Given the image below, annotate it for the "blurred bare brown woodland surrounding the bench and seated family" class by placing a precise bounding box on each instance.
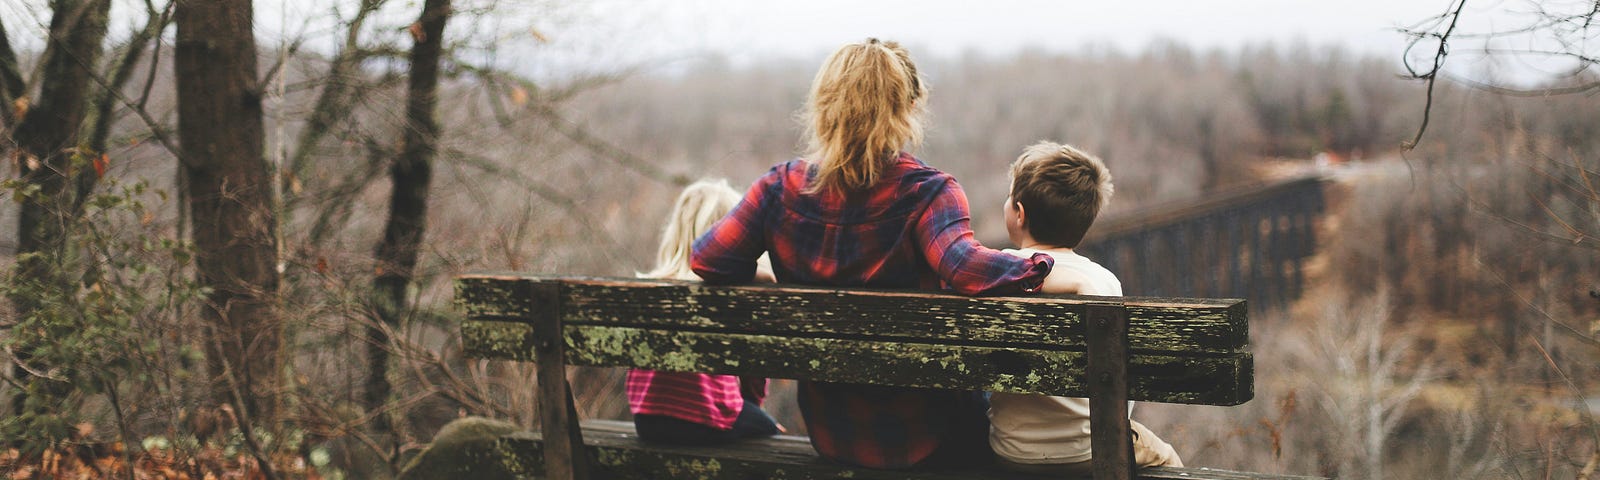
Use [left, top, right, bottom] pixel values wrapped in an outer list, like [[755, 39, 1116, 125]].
[[0, 0, 1600, 478]]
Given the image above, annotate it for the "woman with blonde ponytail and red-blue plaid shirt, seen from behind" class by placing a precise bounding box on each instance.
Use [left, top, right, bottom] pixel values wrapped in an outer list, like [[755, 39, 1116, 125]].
[[691, 38, 1053, 469]]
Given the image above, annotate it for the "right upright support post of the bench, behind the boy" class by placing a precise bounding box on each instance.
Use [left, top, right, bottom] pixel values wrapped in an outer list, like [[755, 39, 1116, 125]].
[[1083, 304, 1134, 480]]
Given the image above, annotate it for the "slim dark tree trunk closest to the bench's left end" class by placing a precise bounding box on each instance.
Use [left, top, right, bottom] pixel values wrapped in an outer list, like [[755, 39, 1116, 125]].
[[365, 0, 450, 430]]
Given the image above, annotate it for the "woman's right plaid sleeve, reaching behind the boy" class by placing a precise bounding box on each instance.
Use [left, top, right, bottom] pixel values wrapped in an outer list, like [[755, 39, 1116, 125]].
[[915, 179, 1056, 294]]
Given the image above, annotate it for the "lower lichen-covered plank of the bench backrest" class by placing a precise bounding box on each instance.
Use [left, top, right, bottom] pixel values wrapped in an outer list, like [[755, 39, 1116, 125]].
[[544, 322, 1253, 405]]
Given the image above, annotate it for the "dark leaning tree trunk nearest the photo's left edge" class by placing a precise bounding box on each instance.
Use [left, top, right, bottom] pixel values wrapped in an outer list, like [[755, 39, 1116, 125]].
[[0, 0, 110, 413]]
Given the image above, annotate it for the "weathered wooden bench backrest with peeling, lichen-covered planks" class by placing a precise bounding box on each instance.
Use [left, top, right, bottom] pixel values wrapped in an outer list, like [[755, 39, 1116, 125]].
[[456, 274, 1254, 405]]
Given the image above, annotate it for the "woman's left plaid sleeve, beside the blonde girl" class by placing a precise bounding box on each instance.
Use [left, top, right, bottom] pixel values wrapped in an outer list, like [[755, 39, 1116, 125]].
[[690, 170, 778, 285]]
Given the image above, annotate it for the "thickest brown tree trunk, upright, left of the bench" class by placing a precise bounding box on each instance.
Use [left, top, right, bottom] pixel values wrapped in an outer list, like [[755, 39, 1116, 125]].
[[174, 0, 283, 424]]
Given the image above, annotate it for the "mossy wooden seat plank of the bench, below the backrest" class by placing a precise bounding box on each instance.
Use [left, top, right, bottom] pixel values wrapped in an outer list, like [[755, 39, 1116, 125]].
[[498, 422, 1314, 480]]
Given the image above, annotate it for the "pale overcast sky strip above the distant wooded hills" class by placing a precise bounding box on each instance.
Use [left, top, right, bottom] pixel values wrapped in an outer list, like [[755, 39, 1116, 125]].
[[492, 0, 1568, 81]]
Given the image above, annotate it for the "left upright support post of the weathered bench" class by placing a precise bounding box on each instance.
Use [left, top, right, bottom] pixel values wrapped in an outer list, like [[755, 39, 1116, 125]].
[[528, 283, 589, 480]]
